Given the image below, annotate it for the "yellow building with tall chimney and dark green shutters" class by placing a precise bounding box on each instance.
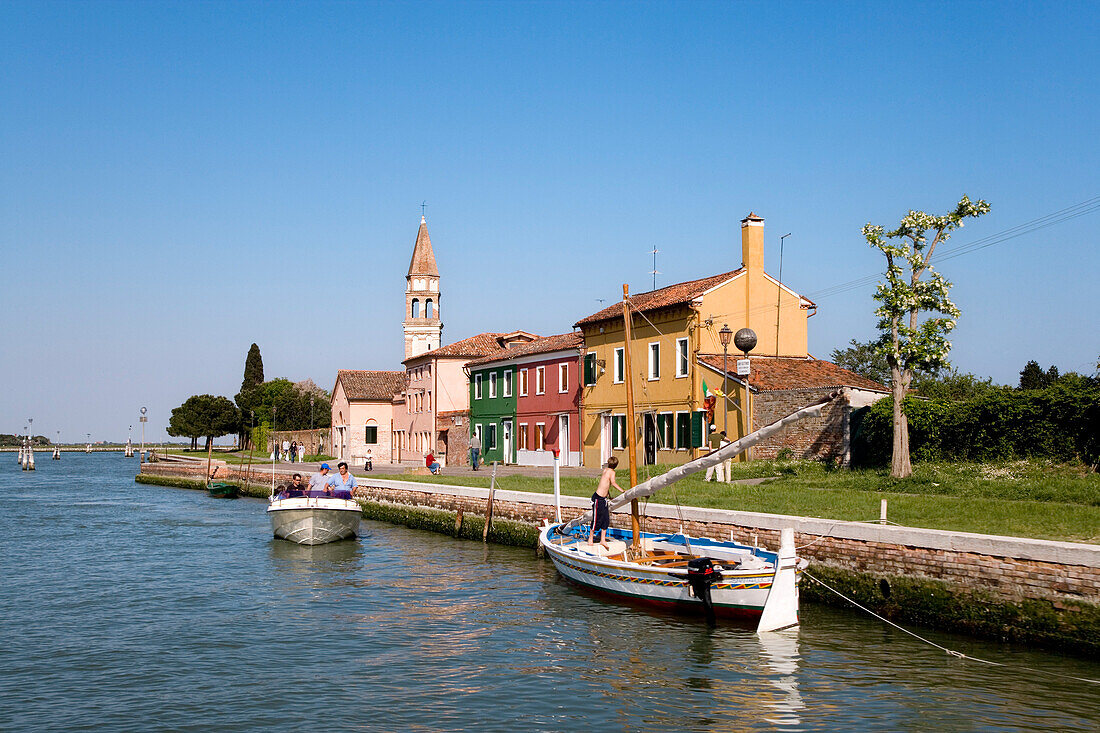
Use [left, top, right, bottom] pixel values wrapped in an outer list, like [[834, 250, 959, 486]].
[[575, 214, 816, 466]]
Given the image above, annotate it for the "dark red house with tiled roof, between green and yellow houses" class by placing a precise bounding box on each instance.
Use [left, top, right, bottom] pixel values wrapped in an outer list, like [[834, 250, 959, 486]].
[[466, 332, 584, 466]]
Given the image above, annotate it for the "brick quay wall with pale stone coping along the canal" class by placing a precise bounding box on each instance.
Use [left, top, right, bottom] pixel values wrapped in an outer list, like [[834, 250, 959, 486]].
[[142, 461, 1100, 657]]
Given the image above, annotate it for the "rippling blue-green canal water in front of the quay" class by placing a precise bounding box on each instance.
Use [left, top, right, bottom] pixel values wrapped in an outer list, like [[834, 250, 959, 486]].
[[0, 453, 1100, 731]]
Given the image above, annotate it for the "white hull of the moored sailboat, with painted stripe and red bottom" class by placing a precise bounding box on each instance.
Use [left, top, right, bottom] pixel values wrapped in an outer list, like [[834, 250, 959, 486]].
[[539, 526, 805, 619]]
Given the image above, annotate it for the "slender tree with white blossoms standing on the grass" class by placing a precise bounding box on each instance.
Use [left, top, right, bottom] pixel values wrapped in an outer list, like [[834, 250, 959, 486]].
[[864, 196, 989, 479]]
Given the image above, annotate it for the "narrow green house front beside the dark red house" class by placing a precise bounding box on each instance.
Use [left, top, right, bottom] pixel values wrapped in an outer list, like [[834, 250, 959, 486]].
[[470, 363, 516, 463]]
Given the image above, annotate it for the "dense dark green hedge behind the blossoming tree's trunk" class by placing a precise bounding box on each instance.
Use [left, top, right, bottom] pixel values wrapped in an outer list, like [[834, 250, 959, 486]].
[[851, 384, 1100, 466]]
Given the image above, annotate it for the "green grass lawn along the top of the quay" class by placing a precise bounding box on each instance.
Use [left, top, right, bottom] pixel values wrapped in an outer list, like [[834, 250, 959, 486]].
[[385, 460, 1100, 543]]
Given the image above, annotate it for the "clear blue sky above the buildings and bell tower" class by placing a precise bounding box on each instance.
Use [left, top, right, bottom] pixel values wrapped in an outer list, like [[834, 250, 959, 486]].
[[0, 2, 1100, 440]]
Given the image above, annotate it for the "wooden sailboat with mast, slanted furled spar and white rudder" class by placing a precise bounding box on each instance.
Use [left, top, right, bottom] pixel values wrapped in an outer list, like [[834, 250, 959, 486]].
[[539, 285, 835, 632]]
